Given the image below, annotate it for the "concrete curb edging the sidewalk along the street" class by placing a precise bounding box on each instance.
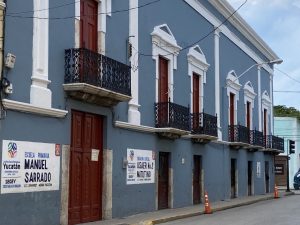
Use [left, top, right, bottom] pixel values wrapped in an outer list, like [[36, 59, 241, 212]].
[[149, 192, 295, 225]]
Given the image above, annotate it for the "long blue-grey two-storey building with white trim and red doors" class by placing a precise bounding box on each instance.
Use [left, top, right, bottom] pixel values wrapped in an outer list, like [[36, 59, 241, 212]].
[[0, 0, 283, 225]]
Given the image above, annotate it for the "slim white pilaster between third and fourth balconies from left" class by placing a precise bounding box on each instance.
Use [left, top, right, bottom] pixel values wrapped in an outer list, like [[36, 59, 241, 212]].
[[214, 29, 222, 140]]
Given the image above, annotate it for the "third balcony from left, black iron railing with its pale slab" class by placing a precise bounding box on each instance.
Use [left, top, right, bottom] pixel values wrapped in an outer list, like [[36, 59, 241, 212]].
[[191, 113, 218, 143]]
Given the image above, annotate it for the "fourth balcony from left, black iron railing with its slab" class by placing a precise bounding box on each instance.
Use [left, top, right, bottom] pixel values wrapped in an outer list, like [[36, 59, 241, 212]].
[[228, 125, 250, 148]]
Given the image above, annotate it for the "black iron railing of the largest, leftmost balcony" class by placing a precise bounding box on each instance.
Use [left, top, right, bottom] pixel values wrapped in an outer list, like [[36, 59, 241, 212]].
[[65, 48, 131, 96]]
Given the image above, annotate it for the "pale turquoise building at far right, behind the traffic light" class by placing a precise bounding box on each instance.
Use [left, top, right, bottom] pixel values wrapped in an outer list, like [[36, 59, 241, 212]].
[[274, 117, 300, 188]]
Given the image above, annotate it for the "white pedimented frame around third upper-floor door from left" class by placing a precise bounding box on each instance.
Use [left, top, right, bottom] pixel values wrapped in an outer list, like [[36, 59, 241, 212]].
[[187, 45, 210, 113]]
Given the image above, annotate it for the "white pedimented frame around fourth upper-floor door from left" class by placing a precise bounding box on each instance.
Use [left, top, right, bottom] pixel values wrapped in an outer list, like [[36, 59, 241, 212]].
[[226, 70, 242, 125]]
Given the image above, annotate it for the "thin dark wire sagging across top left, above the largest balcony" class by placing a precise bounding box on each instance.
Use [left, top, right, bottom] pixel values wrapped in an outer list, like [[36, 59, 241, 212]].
[[6, 0, 162, 20]]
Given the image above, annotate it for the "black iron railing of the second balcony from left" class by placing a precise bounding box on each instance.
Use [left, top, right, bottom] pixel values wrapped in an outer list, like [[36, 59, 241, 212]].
[[155, 101, 190, 131]]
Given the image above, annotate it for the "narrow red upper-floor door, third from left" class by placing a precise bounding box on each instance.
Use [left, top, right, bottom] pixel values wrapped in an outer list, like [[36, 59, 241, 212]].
[[193, 73, 200, 130]]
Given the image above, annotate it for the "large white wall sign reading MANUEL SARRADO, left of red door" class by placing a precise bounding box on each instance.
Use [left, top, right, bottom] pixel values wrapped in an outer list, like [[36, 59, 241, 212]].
[[1, 140, 60, 194]]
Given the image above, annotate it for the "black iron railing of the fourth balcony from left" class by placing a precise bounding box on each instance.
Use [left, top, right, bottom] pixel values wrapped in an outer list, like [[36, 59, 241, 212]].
[[228, 125, 250, 144]]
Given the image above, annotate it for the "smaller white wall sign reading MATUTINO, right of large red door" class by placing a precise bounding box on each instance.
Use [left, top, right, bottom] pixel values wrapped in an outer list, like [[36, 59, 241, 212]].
[[126, 149, 155, 184]]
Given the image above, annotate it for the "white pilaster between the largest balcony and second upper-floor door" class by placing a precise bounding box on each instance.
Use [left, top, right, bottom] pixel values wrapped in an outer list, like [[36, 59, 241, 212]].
[[128, 0, 141, 125]]
